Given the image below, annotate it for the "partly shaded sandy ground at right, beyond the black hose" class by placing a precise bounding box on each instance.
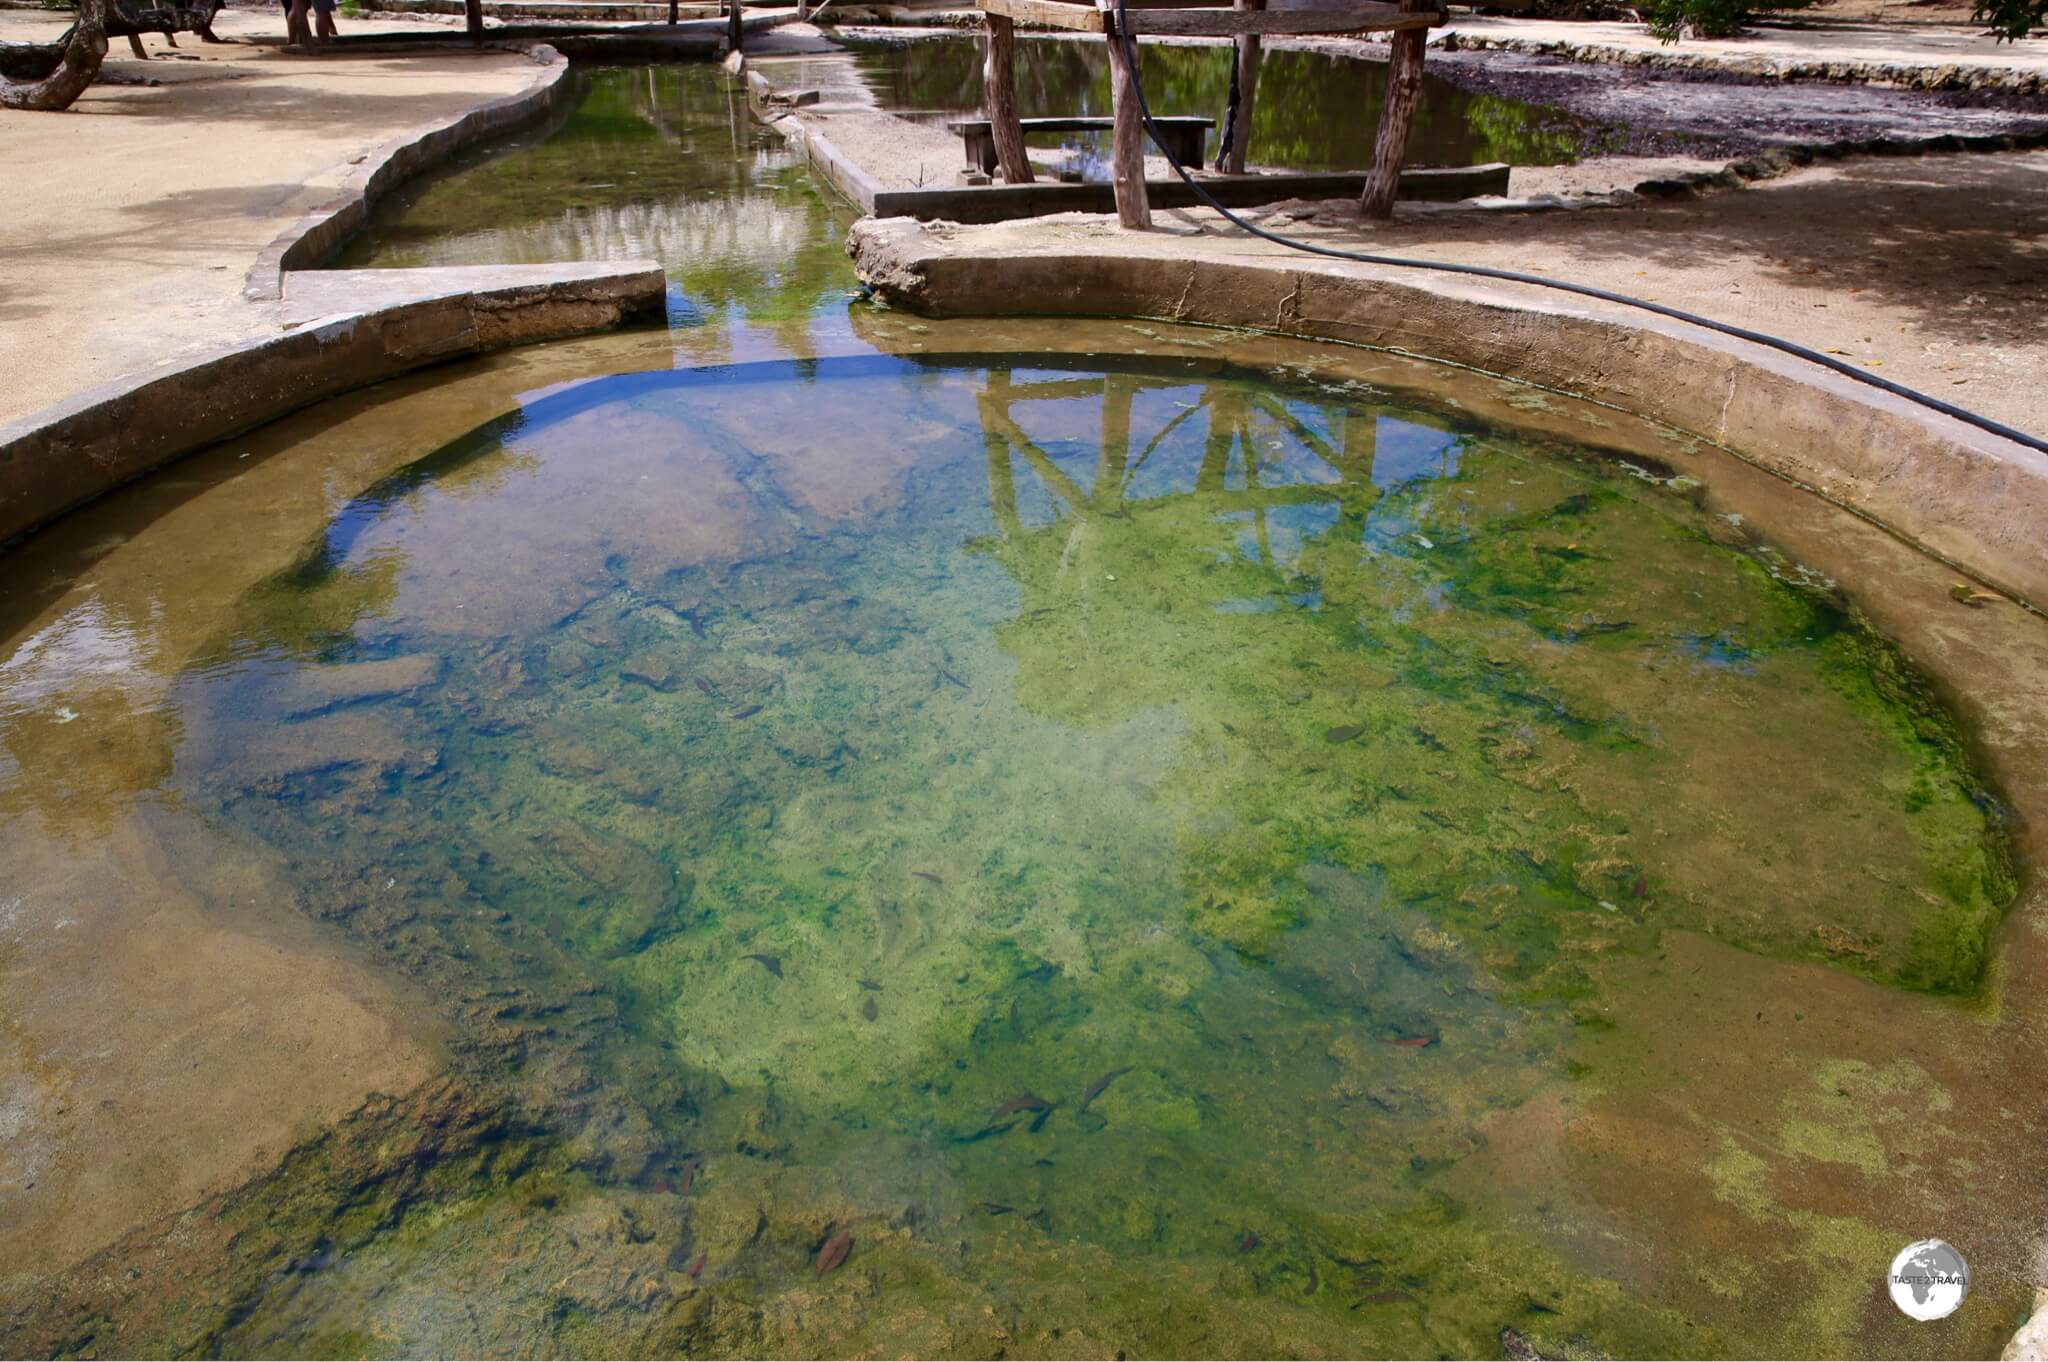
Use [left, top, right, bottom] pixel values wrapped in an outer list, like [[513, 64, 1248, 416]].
[[1210, 152, 2048, 434]]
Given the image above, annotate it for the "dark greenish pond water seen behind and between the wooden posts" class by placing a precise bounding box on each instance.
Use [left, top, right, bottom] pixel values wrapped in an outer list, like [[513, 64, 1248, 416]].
[[846, 37, 1602, 178]]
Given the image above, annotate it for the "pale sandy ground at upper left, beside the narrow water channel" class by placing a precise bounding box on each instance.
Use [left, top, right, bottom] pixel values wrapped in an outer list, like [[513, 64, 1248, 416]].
[[0, 10, 537, 424]]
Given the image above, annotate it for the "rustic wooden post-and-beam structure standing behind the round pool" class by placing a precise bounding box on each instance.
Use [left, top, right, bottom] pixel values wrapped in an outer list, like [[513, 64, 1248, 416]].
[[977, 0, 1444, 227]]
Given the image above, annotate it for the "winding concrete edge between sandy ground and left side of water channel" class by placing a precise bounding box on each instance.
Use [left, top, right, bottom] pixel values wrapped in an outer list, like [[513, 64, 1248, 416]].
[[242, 43, 569, 303]]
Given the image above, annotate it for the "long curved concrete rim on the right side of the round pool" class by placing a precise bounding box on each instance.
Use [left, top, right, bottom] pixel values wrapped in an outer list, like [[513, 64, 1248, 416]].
[[848, 217, 2048, 608]]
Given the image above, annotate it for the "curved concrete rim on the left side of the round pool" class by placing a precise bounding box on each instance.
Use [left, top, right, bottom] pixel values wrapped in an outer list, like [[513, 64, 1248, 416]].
[[0, 260, 668, 543]]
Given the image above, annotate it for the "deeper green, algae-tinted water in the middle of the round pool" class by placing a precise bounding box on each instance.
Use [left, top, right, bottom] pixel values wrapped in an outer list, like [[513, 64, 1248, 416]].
[[108, 356, 2011, 1354]]
